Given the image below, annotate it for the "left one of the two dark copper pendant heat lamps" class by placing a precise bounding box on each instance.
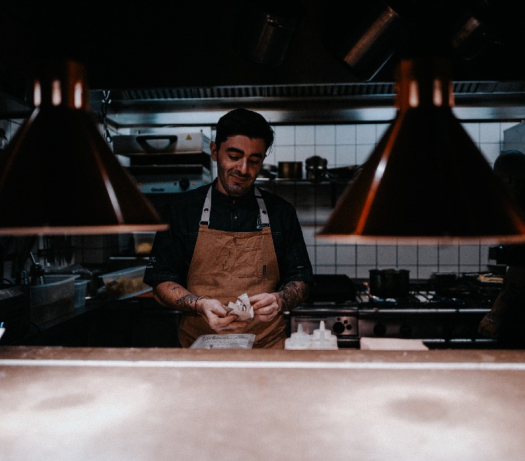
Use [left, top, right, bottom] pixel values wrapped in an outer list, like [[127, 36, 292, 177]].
[[0, 61, 167, 235]]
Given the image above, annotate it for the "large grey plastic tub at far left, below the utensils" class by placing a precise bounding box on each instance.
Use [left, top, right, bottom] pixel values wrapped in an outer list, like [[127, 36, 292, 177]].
[[29, 275, 79, 324]]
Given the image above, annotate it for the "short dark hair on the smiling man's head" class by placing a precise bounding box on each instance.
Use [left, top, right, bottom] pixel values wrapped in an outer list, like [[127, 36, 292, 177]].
[[215, 108, 275, 155]]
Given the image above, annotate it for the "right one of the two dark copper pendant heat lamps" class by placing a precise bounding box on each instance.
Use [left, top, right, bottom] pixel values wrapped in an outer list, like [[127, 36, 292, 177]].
[[317, 57, 525, 244]]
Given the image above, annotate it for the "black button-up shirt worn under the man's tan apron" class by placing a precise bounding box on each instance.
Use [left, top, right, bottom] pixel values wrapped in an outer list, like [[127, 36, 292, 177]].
[[144, 183, 313, 289]]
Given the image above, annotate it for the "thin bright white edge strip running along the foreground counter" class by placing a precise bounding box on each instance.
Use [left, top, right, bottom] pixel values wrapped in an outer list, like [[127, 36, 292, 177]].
[[0, 359, 525, 371]]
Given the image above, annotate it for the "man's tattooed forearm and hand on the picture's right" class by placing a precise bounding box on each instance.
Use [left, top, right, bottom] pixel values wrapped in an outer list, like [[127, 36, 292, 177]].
[[250, 282, 309, 322]]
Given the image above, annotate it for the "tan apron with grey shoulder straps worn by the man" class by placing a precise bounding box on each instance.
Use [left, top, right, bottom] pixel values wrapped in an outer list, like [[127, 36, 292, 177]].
[[179, 186, 286, 348]]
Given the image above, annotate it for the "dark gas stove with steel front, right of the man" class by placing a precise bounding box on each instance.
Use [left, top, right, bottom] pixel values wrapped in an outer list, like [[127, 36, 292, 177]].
[[290, 274, 502, 349]]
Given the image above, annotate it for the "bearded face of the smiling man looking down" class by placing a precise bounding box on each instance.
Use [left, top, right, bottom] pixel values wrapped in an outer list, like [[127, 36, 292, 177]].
[[210, 135, 266, 197]]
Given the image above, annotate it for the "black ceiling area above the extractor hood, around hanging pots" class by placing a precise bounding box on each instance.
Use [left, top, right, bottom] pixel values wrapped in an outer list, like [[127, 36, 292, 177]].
[[0, 0, 525, 89]]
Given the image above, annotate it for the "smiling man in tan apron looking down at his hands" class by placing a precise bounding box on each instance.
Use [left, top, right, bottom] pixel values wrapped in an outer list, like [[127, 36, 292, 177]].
[[144, 108, 313, 348]]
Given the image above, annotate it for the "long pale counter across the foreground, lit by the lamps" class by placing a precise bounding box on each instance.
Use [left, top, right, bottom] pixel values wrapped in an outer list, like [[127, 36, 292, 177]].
[[0, 347, 525, 461]]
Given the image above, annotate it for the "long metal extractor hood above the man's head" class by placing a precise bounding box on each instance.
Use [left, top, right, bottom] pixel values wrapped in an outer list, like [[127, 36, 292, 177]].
[[91, 80, 525, 128]]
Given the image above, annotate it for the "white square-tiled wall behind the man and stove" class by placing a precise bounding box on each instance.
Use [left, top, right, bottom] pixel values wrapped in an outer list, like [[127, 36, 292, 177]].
[[2, 121, 510, 279]]
